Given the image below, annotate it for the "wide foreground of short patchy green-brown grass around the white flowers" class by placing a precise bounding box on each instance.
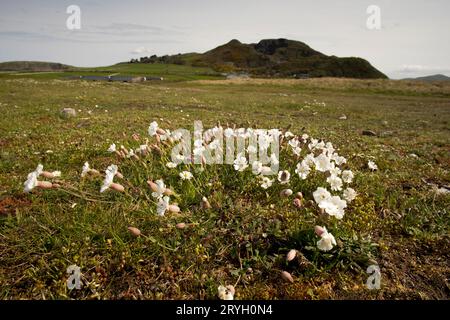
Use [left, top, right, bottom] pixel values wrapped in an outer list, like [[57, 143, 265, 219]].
[[0, 76, 450, 299]]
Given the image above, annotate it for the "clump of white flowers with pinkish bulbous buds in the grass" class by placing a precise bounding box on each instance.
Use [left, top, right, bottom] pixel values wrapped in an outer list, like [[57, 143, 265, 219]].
[[24, 121, 377, 255]]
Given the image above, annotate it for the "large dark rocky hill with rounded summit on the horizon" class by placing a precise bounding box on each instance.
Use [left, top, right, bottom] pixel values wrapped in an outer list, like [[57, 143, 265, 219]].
[[133, 39, 387, 79]]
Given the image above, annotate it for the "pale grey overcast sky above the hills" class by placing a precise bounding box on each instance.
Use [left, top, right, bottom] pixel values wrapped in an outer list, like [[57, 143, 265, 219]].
[[0, 0, 450, 78]]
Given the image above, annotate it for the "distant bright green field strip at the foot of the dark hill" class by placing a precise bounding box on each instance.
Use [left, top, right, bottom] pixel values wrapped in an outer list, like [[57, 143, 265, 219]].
[[0, 63, 223, 81]]
